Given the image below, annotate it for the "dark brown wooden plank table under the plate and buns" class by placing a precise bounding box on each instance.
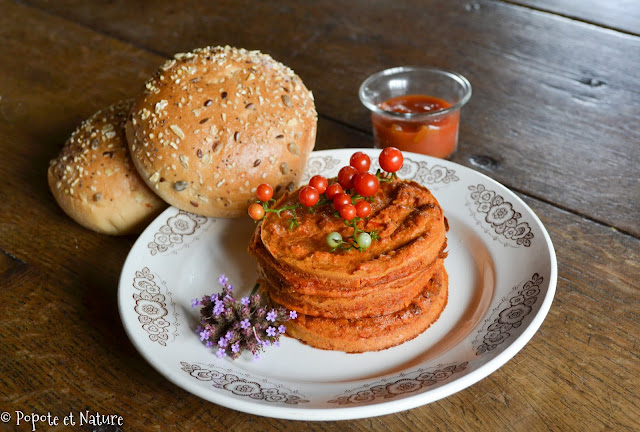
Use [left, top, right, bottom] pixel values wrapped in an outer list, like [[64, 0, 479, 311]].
[[0, 0, 640, 431]]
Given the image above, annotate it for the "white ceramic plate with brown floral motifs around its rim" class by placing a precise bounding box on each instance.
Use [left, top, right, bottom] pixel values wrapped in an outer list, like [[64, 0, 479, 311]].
[[118, 149, 557, 420]]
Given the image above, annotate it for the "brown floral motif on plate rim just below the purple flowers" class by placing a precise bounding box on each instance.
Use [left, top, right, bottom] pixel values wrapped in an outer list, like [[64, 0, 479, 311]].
[[180, 362, 309, 405]]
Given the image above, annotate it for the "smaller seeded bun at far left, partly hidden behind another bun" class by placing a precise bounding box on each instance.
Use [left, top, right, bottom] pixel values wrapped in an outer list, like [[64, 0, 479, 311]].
[[48, 101, 166, 235]]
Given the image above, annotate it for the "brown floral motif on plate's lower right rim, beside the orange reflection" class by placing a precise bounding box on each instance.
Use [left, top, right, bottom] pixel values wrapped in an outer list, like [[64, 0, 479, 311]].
[[476, 273, 544, 355]]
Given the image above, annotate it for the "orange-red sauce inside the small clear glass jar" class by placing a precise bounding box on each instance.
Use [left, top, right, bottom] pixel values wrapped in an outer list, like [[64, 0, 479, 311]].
[[371, 95, 460, 158]]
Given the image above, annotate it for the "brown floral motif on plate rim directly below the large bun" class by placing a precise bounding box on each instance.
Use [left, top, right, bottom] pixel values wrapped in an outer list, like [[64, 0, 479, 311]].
[[147, 210, 214, 255]]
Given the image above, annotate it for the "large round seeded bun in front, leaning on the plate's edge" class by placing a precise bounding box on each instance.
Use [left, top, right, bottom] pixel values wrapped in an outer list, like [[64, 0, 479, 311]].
[[126, 46, 317, 217]]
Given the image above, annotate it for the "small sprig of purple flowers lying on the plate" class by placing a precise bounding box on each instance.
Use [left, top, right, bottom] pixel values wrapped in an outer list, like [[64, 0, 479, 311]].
[[191, 275, 297, 360]]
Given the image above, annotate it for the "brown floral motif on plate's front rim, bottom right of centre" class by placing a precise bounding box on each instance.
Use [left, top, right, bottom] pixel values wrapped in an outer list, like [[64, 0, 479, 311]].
[[329, 362, 468, 405]]
